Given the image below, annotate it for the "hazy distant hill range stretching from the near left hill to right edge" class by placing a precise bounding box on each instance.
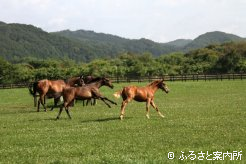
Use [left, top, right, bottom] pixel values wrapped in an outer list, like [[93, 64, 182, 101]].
[[52, 30, 244, 56]]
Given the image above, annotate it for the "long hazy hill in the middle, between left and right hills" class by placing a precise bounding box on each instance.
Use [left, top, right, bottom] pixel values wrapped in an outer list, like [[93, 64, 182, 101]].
[[54, 30, 178, 56]]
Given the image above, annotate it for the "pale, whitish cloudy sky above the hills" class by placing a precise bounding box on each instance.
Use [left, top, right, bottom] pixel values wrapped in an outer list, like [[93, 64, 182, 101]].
[[0, 0, 246, 43]]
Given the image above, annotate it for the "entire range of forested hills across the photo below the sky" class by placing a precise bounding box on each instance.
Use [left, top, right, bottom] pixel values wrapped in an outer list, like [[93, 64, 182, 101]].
[[0, 22, 243, 63]]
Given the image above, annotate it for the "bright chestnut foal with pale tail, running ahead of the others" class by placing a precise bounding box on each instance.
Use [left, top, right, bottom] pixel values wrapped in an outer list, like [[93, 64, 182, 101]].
[[113, 80, 169, 120]]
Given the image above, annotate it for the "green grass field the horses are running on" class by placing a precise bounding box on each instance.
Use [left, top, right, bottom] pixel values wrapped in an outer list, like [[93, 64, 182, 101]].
[[0, 80, 246, 163]]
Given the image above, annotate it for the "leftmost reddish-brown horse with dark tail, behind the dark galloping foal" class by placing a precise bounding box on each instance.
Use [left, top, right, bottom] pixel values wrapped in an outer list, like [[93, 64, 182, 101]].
[[29, 76, 84, 112]]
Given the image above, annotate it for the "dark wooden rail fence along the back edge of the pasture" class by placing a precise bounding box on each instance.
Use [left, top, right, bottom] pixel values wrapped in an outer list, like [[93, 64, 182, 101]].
[[0, 74, 246, 89]]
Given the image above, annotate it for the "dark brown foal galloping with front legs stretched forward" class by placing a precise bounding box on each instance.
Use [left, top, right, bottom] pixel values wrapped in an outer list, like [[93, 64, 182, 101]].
[[56, 78, 117, 119]]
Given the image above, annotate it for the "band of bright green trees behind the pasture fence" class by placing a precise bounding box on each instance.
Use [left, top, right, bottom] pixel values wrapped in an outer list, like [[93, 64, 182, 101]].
[[0, 42, 246, 84]]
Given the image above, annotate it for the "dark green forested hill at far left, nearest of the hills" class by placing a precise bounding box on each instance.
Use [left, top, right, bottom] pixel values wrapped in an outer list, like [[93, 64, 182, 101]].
[[0, 23, 98, 61]]
